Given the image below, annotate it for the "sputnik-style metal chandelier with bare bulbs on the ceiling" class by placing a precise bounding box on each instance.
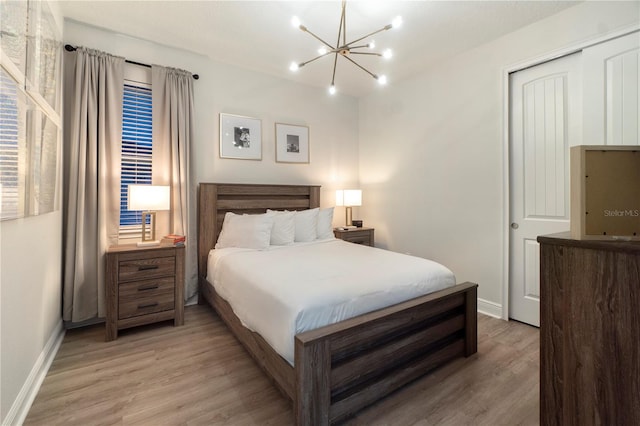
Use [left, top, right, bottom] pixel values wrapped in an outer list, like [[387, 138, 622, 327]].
[[289, 0, 402, 95]]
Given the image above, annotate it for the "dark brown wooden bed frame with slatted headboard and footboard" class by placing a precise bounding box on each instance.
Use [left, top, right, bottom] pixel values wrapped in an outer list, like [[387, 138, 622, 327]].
[[198, 183, 477, 425]]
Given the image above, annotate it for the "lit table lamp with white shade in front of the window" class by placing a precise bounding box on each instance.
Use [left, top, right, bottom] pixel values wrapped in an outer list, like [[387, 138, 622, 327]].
[[127, 185, 171, 247]]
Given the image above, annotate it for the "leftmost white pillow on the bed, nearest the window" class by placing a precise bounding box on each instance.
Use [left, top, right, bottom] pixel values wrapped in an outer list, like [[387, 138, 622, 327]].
[[216, 212, 273, 250]]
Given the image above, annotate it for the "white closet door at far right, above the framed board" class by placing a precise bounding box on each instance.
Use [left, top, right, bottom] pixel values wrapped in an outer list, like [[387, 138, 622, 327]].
[[582, 32, 640, 145]]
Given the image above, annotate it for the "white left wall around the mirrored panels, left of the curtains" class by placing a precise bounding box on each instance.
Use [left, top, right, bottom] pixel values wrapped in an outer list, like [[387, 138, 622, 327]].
[[0, 3, 62, 425]]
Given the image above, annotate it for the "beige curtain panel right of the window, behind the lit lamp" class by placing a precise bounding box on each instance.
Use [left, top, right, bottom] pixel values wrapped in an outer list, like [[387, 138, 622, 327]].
[[151, 65, 198, 300]]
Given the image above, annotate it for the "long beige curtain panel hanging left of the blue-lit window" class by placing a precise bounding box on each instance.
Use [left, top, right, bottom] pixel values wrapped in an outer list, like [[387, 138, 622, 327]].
[[63, 47, 124, 322]]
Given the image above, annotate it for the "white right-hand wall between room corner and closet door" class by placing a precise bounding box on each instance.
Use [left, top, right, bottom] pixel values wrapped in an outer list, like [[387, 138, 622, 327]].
[[359, 2, 640, 312]]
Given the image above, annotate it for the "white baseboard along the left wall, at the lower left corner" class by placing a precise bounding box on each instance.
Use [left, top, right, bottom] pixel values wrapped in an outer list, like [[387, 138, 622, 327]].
[[2, 319, 65, 426]]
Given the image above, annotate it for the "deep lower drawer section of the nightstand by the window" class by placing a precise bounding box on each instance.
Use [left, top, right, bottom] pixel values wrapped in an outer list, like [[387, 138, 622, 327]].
[[118, 277, 175, 319]]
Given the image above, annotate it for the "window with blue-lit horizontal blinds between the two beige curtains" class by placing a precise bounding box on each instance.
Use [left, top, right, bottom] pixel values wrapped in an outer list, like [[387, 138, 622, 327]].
[[120, 80, 153, 237]]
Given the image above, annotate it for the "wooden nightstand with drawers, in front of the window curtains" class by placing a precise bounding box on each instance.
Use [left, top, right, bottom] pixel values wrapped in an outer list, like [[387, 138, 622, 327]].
[[106, 244, 184, 341]]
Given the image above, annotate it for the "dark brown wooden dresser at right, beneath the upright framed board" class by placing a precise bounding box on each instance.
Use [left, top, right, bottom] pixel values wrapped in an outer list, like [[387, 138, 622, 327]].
[[538, 233, 640, 426]]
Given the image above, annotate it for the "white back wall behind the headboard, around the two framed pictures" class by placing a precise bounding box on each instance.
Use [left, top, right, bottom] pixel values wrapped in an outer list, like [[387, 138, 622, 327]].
[[65, 21, 358, 296]]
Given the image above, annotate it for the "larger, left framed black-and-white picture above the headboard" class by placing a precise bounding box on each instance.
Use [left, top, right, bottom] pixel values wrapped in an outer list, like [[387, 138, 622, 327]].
[[220, 113, 262, 160]]
